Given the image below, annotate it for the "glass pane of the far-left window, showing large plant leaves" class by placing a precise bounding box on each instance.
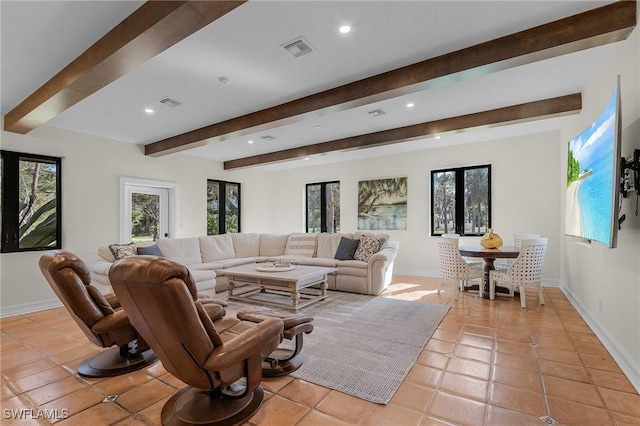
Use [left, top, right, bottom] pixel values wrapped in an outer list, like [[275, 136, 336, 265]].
[[18, 159, 58, 249]]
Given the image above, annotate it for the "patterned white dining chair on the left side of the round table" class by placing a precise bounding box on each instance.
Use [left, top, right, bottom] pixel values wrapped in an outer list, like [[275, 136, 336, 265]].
[[437, 238, 484, 299]]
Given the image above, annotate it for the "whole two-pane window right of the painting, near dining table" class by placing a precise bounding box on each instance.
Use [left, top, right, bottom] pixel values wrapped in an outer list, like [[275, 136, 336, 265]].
[[431, 165, 491, 235]]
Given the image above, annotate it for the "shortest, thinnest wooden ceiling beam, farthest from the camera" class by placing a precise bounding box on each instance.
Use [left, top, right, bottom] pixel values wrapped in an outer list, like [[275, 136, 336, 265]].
[[224, 93, 582, 170]]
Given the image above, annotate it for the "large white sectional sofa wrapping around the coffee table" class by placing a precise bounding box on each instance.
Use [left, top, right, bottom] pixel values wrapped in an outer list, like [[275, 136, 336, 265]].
[[83, 232, 399, 295]]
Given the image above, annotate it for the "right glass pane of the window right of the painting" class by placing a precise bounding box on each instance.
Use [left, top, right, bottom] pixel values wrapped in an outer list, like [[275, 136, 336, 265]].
[[464, 167, 489, 234]]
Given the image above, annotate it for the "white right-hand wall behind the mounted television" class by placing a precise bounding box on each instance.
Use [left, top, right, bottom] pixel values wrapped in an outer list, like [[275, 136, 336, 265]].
[[559, 28, 640, 391]]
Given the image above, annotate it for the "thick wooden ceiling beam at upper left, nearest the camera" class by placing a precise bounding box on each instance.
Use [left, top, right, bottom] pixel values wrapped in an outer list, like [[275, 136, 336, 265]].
[[4, 0, 246, 134]]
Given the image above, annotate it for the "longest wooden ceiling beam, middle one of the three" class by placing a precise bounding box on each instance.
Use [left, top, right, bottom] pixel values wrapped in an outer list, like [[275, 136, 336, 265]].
[[145, 1, 636, 156]]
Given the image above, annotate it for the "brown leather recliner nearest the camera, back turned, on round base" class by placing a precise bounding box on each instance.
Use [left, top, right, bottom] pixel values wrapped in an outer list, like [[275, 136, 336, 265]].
[[109, 257, 283, 425]]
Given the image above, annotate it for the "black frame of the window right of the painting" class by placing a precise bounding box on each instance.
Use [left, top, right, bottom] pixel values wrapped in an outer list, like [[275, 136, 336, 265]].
[[430, 164, 492, 237]]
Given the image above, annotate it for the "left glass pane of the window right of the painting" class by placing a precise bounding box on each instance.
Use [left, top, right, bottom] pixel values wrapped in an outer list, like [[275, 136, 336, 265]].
[[432, 171, 456, 234]]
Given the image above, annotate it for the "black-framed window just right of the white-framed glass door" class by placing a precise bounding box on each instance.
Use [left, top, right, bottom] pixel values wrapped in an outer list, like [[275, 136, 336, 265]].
[[207, 180, 240, 235]]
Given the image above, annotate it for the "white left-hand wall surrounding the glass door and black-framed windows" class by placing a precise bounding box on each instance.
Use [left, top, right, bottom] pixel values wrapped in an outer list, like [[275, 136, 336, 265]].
[[0, 126, 273, 312]]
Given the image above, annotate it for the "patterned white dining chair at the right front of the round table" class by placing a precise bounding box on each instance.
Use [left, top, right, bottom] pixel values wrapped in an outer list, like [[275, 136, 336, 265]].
[[489, 238, 548, 308]]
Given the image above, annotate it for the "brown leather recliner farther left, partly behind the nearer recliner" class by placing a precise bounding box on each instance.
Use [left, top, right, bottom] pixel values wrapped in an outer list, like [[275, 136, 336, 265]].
[[38, 250, 157, 377]]
